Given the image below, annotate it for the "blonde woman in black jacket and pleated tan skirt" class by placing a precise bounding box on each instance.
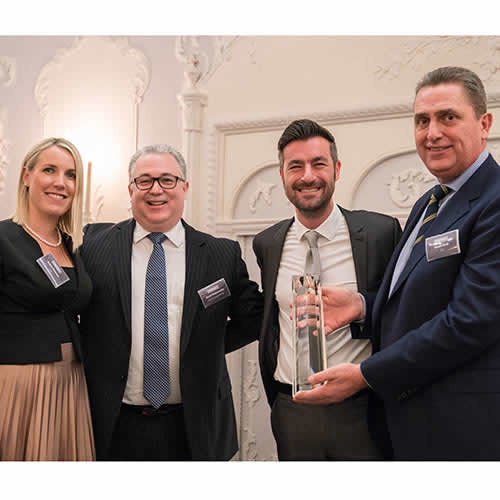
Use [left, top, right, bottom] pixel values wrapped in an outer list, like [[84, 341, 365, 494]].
[[0, 138, 95, 460]]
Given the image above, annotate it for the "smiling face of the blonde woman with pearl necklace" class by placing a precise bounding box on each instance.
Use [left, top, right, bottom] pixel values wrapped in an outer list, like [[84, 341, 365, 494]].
[[23, 146, 76, 222]]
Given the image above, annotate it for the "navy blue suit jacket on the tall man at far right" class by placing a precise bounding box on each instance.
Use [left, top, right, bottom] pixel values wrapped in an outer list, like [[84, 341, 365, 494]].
[[361, 155, 500, 460]]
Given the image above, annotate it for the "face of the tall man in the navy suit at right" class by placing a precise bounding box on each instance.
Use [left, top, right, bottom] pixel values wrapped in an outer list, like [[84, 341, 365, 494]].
[[415, 83, 492, 183]]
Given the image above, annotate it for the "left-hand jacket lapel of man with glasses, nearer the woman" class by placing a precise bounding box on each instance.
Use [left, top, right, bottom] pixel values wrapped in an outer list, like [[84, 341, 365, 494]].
[[111, 219, 135, 335]]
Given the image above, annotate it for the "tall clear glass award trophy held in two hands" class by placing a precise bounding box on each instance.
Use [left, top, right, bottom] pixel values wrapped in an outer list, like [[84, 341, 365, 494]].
[[292, 274, 327, 396]]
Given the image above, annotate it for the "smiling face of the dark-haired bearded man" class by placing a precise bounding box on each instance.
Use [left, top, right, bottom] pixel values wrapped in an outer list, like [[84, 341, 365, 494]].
[[280, 137, 340, 229]]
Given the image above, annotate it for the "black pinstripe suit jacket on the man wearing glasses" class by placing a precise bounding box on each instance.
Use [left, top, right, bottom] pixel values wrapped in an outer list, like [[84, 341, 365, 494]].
[[81, 219, 262, 460]]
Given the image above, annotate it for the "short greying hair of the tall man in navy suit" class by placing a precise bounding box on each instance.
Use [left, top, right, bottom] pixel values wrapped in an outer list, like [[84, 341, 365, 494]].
[[415, 66, 487, 119]]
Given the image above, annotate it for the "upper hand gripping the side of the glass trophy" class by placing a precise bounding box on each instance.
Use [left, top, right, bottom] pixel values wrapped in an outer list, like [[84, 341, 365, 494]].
[[321, 286, 365, 335]]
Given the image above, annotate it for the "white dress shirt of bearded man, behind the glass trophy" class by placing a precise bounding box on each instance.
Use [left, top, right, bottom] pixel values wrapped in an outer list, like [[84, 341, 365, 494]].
[[274, 204, 372, 384]]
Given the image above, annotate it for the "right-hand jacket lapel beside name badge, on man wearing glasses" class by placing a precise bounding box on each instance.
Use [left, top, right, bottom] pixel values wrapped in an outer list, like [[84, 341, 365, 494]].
[[181, 221, 209, 355]]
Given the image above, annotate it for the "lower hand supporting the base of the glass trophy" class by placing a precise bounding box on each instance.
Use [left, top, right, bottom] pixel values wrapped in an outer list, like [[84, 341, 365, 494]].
[[293, 363, 368, 405]]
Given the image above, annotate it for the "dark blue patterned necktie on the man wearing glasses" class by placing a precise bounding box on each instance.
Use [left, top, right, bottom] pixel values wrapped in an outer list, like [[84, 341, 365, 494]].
[[144, 233, 170, 408]]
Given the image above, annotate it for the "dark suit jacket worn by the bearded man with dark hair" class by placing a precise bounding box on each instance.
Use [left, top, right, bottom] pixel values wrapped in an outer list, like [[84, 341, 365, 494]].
[[253, 208, 401, 455]]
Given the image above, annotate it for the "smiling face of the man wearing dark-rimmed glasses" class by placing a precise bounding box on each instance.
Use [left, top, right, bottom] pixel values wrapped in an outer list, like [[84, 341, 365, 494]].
[[128, 153, 189, 232]]
